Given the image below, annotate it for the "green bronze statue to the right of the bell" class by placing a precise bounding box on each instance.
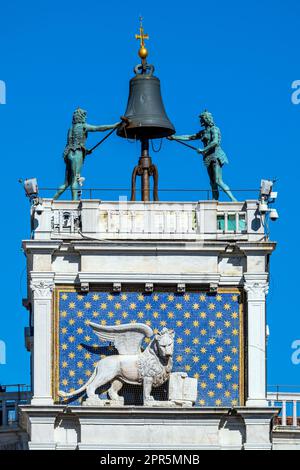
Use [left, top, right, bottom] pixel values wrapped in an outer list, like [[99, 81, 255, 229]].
[[168, 111, 236, 201]]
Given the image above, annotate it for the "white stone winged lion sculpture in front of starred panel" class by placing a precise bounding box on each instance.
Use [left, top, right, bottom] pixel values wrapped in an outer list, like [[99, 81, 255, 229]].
[[58, 322, 175, 404]]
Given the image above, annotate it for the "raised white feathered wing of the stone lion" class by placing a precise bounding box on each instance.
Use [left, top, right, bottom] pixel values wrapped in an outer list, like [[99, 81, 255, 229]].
[[89, 322, 154, 354]]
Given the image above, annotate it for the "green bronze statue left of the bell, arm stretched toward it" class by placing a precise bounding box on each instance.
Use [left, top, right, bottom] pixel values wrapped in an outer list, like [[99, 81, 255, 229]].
[[53, 108, 121, 201]]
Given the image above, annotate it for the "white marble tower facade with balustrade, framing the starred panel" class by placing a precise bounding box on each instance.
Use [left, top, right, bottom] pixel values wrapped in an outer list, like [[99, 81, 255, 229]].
[[22, 199, 278, 449]]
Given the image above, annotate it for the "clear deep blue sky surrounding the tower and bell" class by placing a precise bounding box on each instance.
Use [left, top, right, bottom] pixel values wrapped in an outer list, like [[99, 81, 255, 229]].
[[0, 0, 300, 390]]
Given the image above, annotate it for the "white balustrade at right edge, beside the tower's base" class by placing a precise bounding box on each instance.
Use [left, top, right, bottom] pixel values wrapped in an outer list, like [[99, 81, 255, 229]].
[[267, 385, 300, 427]]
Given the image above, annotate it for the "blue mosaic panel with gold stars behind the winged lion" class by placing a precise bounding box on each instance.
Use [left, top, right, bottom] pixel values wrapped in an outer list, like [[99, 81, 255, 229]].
[[56, 291, 243, 407]]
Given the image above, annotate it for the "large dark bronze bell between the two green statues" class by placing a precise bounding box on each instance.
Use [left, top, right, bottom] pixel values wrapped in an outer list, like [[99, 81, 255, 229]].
[[117, 64, 175, 140]]
